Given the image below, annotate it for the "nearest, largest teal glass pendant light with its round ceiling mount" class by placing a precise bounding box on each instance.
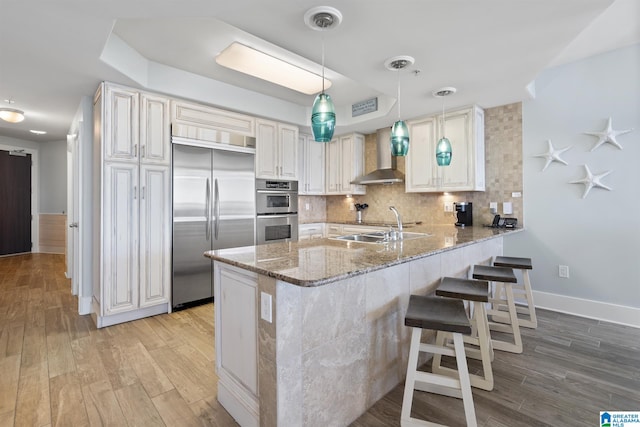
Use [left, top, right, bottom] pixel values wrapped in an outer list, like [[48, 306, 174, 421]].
[[304, 6, 342, 142]]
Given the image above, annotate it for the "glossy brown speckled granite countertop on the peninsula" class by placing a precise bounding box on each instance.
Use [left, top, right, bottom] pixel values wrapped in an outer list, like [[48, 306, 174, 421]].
[[204, 225, 522, 287]]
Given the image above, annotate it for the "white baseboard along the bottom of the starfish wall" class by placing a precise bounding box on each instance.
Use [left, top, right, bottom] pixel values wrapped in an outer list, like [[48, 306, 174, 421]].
[[533, 291, 640, 328]]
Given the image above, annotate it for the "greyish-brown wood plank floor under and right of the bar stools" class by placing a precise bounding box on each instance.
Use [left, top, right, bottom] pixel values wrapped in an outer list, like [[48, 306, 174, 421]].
[[352, 300, 640, 427]]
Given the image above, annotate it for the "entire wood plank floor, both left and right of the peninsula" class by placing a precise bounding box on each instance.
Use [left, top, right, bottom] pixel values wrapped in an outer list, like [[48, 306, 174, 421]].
[[0, 254, 640, 427]]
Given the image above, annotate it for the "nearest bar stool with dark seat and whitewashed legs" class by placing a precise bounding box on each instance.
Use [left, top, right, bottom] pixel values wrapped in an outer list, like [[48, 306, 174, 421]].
[[400, 295, 477, 427]]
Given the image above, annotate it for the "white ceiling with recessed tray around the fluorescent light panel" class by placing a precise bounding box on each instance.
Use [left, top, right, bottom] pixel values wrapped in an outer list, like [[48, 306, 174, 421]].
[[0, 0, 640, 142]]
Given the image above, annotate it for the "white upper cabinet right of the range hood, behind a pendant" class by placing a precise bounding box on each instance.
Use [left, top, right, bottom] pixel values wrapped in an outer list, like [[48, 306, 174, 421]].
[[405, 106, 485, 192]]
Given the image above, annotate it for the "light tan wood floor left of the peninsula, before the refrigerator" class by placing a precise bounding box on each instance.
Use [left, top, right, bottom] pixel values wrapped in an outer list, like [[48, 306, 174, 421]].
[[0, 254, 237, 427]]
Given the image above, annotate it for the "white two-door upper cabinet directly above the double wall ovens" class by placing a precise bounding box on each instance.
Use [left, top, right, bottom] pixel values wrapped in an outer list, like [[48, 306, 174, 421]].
[[256, 119, 299, 181]]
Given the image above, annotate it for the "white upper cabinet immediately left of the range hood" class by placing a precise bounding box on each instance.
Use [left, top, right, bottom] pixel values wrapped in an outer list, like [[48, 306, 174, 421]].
[[325, 133, 366, 194]]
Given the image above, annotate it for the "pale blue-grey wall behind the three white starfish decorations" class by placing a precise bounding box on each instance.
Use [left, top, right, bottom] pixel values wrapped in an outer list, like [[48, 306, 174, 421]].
[[504, 45, 640, 326]]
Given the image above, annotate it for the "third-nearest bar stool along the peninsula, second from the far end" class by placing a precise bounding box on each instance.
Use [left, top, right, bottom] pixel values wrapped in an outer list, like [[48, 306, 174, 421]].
[[473, 265, 522, 353]]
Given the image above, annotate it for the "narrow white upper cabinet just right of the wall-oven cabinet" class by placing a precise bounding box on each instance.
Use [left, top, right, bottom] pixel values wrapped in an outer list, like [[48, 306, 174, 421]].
[[298, 134, 326, 195]]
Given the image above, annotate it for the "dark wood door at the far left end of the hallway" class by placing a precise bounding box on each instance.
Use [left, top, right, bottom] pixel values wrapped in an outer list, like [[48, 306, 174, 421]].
[[0, 150, 31, 255]]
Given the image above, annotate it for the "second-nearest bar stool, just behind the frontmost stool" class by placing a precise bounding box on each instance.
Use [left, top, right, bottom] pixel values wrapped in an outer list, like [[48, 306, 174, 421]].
[[431, 277, 493, 391]]
